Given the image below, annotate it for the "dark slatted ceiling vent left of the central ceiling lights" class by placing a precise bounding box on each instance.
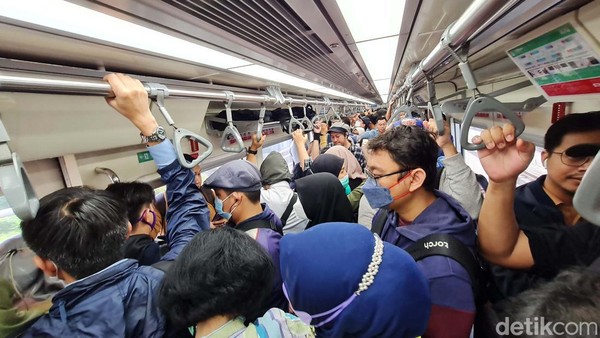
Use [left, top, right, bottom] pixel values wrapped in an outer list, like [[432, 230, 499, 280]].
[[163, 0, 365, 95]]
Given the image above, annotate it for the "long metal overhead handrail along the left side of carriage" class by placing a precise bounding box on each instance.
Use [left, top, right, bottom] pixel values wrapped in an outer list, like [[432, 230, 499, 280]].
[[0, 71, 364, 106]]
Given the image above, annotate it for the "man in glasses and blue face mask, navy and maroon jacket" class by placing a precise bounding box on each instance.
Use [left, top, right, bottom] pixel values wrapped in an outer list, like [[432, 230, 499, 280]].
[[363, 126, 475, 337]]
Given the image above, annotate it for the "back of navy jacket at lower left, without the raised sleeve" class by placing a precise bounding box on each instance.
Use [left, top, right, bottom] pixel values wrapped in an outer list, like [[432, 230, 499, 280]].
[[24, 259, 166, 337]]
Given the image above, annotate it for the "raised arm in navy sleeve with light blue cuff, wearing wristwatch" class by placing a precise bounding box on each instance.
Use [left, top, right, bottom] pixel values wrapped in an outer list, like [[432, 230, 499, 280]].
[[104, 74, 209, 261]]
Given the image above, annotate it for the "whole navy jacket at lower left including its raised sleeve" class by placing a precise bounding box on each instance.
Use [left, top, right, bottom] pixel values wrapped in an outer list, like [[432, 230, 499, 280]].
[[24, 141, 209, 337]]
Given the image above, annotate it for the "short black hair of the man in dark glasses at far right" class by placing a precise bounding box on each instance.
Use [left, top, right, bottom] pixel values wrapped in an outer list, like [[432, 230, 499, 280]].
[[544, 111, 600, 153]]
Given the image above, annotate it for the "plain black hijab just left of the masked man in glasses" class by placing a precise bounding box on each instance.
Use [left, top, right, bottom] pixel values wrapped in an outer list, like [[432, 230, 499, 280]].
[[295, 173, 354, 229]]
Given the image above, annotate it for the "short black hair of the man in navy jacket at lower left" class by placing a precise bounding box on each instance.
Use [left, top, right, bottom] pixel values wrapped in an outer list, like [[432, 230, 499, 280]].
[[21, 187, 128, 279]]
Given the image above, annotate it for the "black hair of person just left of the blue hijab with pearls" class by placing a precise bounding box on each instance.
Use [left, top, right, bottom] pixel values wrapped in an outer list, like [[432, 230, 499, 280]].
[[159, 227, 275, 328]]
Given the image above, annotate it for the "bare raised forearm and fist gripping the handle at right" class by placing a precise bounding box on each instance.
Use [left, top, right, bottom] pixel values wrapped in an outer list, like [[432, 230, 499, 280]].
[[473, 124, 535, 269]]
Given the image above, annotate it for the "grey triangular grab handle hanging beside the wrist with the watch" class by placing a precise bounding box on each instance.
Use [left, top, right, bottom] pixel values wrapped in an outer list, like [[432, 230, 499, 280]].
[[144, 82, 213, 169]]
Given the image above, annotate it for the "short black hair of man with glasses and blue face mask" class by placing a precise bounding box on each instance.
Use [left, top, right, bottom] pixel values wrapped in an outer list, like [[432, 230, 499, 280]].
[[367, 125, 438, 190]]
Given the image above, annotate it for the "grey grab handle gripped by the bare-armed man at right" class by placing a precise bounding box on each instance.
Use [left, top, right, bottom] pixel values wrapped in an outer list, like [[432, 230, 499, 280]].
[[460, 94, 525, 150]]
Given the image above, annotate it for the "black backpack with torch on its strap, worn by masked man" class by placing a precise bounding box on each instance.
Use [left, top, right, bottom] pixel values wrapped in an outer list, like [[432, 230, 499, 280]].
[[371, 209, 498, 338]]
